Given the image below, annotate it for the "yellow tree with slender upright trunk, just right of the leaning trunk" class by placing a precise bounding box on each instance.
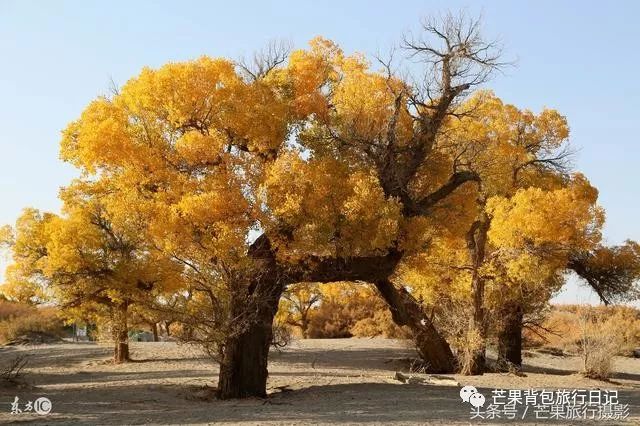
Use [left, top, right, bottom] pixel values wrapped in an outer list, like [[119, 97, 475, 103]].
[[396, 92, 594, 374]]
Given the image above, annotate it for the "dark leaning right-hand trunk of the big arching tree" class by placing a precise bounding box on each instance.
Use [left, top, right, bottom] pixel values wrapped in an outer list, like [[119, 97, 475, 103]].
[[375, 280, 456, 373]]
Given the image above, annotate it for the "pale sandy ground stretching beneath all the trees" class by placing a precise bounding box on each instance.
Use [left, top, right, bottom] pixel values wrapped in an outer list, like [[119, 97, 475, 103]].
[[0, 339, 640, 425]]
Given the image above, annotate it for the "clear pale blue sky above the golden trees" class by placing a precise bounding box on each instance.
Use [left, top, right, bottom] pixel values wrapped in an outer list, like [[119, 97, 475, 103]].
[[0, 0, 640, 301]]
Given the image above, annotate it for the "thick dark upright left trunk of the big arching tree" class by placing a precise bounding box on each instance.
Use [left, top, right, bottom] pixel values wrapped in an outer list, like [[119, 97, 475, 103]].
[[218, 276, 284, 399]]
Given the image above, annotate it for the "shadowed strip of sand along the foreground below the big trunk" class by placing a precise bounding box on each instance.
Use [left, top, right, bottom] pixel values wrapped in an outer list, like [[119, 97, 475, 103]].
[[5, 383, 640, 424]]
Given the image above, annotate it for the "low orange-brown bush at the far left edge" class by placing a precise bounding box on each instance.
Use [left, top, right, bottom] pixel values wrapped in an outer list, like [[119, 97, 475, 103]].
[[0, 307, 64, 344]]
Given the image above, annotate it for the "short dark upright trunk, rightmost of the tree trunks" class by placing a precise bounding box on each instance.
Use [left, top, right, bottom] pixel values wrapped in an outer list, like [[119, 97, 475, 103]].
[[498, 302, 523, 370]]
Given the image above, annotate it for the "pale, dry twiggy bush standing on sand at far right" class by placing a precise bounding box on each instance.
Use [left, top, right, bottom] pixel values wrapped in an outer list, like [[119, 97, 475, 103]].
[[578, 308, 624, 380]]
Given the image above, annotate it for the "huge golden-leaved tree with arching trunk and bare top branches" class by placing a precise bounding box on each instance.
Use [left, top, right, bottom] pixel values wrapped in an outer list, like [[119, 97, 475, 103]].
[[47, 16, 636, 398]]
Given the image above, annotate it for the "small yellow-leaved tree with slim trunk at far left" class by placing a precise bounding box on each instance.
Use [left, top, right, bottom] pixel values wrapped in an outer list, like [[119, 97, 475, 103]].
[[6, 182, 180, 363]]
